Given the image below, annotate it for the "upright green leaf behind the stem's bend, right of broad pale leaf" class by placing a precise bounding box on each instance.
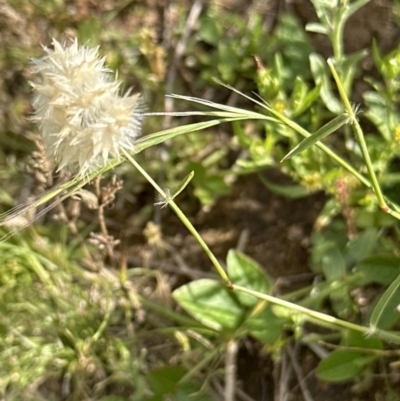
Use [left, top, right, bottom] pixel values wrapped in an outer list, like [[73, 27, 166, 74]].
[[226, 249, 271, 307]]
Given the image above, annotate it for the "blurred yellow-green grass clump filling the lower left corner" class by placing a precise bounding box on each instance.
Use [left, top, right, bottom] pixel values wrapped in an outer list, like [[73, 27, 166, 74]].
[[0, 236, 148, 400]]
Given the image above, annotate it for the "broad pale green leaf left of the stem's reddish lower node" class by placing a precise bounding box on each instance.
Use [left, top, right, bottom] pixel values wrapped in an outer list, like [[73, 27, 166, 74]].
[[173, 279, 244, 331]]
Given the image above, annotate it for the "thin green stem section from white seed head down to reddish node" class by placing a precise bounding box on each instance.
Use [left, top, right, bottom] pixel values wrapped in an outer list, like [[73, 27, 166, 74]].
[[123, 150, 232, 288]]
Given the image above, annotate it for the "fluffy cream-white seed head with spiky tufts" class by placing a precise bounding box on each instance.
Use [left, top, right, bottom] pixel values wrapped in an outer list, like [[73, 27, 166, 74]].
[[31, 39, 143, 176]]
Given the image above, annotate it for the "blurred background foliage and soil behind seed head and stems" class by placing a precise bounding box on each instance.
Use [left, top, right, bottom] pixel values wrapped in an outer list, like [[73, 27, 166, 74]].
[[0, 0, 400, 401]]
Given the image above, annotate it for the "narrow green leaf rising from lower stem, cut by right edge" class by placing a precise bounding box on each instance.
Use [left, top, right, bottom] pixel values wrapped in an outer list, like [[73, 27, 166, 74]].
[[369, 275, 400, 330]]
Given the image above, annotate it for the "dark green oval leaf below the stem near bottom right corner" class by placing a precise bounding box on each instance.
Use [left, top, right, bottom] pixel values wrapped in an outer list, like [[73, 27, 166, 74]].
[[316, 350, 376, 382]]
